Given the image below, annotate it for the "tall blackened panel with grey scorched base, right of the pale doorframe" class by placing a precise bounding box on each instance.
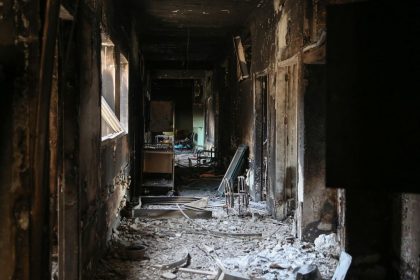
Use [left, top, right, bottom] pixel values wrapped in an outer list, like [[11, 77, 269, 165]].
[[302, 65, 337, 242]]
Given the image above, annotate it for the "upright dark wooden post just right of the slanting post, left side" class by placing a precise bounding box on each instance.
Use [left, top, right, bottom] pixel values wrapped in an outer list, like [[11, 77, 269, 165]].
[[58, 1, 81, 280]]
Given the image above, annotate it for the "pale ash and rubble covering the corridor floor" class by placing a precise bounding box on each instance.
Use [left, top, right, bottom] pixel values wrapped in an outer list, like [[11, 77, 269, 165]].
[[95, 197, 339, 280]]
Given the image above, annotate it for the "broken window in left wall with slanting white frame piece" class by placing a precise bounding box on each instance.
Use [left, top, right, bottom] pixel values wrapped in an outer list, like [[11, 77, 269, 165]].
[[101, 35, 128, 140]]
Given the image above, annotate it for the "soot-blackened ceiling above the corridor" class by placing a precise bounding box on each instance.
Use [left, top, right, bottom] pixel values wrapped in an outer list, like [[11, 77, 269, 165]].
[[127, 0, 263, 69]]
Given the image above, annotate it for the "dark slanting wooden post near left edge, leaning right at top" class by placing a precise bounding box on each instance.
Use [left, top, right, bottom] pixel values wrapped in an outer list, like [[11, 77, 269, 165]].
[[30, 0, 60, 279]]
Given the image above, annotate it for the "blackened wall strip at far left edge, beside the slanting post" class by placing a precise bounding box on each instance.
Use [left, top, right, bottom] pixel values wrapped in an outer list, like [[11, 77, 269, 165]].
[[0, 1, 40, 279]]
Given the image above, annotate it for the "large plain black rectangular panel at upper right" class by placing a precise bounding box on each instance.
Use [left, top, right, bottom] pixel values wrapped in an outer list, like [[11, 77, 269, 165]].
[[327, 1, 420, 192]]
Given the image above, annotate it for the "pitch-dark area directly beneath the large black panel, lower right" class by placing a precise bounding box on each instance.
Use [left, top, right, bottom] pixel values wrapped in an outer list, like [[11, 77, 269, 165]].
[[346, 189, 398, 280]]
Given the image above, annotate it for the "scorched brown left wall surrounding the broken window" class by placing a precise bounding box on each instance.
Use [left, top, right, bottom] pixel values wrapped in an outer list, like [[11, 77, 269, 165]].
[[80, 1, 146, 277]]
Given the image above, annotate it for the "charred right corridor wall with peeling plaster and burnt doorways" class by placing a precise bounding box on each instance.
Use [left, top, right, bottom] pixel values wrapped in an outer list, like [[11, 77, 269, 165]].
[[218, 0, 342, 240]]
